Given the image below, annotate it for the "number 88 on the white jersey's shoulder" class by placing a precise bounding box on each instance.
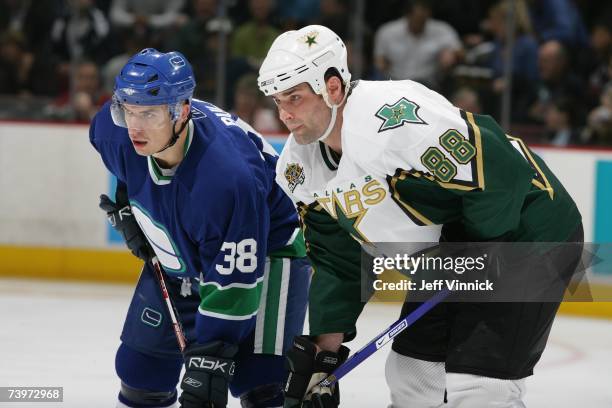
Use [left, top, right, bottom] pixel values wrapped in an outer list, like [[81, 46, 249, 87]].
[[421, 129, 476, 183]]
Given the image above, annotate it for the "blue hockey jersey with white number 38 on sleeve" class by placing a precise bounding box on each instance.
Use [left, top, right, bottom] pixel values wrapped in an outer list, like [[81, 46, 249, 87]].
[[89, 100, 298, 343]]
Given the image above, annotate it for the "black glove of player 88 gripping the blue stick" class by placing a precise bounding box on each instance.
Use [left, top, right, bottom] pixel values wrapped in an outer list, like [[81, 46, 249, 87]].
[[284, 336, 349, 408]]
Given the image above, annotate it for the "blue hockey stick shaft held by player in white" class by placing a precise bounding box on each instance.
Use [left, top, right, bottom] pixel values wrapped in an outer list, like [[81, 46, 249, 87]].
[[318, 289, 450, 387]]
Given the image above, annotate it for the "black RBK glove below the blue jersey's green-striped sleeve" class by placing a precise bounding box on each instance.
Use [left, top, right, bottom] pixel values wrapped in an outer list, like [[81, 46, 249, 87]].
[[179, 340, 238, 408]]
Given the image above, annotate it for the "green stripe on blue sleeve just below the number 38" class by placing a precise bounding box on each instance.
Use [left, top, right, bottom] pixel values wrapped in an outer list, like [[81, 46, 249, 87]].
[[199, 281, 263, 320]]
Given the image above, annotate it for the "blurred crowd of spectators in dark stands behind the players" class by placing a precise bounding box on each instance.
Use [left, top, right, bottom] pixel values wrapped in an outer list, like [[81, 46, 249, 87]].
[[0, 0, 612, 146]]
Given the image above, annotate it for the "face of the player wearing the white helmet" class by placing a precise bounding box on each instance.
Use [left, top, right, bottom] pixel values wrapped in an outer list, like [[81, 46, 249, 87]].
[[272, 83, 331, 145]]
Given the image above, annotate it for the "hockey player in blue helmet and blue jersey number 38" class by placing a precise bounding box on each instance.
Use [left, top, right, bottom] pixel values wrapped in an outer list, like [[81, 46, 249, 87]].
[[90, 49, 310, 408]]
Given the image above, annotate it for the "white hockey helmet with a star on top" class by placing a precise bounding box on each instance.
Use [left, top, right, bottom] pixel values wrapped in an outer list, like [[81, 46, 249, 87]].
[[257, 25, 351, 104]]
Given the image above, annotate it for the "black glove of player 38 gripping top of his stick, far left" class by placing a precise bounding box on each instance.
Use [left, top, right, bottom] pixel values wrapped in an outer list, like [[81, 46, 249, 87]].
[[100, 190, 153, 262]]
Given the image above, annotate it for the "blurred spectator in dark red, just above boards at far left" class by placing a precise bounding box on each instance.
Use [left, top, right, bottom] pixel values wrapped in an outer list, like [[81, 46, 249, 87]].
[[47, 61, 110, 122]]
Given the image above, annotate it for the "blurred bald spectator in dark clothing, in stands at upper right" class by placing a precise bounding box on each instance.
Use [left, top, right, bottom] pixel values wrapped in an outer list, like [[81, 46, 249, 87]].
[[529, 41, 584, 123]]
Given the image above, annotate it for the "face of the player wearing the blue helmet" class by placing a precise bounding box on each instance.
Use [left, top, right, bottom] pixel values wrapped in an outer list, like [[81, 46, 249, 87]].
[[122, 104, 172, 156]]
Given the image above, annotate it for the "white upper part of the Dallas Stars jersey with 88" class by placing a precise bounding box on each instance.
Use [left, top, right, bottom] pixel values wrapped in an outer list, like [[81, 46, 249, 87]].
[[276, 81, 482, 242]]
